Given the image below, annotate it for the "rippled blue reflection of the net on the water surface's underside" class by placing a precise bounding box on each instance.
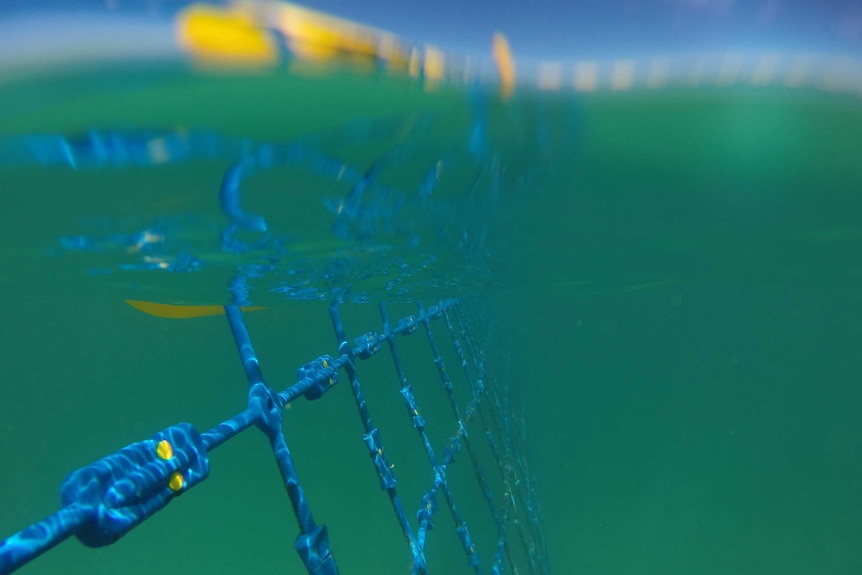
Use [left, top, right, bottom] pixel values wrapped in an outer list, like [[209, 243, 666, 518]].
[[0, 109, 510, 303]]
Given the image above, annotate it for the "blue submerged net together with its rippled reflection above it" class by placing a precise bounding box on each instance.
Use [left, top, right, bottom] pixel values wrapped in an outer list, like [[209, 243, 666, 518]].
[[0, 64, 548, 574]]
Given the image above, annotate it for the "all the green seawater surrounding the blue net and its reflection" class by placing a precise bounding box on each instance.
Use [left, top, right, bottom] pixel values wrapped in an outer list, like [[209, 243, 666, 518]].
[[0, 64, 862, 574]]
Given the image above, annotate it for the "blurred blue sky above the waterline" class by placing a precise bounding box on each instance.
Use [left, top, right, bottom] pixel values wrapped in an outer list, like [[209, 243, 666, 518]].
[[0, 0, 862, 61]]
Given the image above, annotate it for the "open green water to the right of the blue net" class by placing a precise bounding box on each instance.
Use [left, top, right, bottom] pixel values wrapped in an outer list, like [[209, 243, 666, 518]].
[[506, 90, 862, 574]]
